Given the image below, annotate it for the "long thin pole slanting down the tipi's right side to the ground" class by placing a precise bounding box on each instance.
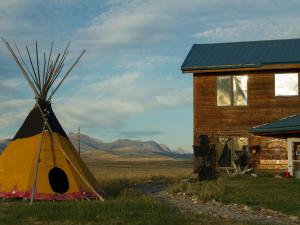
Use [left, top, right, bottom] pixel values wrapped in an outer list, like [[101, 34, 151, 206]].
[[37, 102, 104, 201]]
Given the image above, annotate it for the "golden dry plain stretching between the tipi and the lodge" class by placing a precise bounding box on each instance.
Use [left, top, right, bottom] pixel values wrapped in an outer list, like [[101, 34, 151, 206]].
[[83, 152, 192, 180]]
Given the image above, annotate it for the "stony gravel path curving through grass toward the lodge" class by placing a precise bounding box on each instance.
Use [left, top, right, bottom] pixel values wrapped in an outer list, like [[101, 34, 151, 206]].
[[135, 182, 300, 225]]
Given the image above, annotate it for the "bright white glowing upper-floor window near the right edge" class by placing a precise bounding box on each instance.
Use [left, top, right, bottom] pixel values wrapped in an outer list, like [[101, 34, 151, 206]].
[[275, 73, 299, 96]]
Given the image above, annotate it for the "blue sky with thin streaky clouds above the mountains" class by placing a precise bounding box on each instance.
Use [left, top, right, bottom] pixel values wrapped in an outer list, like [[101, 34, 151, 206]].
[[0, 0, 300, 151]]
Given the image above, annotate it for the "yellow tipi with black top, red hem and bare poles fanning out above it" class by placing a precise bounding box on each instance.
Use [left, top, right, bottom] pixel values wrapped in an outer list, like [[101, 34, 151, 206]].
[[0, 39, 104, 202]]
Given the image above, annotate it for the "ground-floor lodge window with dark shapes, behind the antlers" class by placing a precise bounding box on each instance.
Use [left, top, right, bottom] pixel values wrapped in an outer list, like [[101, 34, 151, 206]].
[[216, 136, 248, 167]]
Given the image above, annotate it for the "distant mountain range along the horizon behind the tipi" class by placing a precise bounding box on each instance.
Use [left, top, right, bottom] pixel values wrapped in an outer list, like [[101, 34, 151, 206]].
[[0, 133, 192, 159]]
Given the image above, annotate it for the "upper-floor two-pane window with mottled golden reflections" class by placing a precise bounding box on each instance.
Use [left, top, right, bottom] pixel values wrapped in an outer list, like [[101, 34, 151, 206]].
[[217, 76, 248, 106]]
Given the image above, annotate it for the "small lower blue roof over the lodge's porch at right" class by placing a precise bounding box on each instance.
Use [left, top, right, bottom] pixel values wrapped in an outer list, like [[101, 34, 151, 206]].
[[250, 114, 300, 135]]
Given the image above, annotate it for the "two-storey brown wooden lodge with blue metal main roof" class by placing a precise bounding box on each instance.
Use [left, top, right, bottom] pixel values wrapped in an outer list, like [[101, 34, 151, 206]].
[[181, 39, 300, 171]]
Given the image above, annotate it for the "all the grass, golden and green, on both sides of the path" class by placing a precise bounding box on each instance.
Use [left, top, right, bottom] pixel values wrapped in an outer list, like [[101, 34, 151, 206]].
[[0, 155, 300, 225]]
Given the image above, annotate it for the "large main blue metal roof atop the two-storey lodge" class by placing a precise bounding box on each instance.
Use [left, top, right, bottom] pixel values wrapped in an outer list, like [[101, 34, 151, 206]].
[[181, 39, 300, 72]]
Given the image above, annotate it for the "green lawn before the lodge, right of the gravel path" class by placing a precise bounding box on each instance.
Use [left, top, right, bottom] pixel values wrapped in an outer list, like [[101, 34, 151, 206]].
[[218, 177, 300, 217]]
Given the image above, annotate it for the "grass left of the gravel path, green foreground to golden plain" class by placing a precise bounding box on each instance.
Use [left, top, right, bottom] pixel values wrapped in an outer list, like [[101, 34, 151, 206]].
[[0, 158, 260, 225]]
